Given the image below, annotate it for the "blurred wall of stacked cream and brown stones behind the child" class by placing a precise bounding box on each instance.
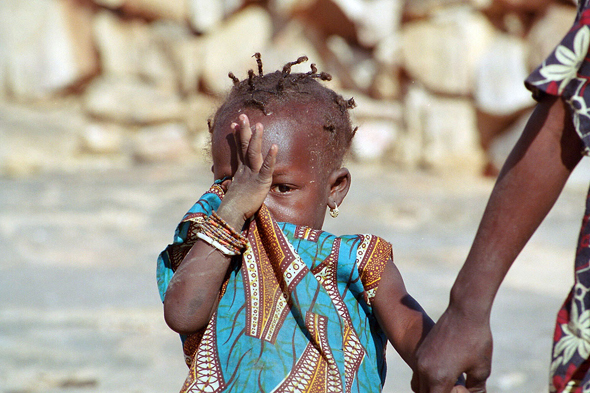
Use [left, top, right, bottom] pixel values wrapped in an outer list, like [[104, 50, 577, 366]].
[[0, 0, 575, 177]]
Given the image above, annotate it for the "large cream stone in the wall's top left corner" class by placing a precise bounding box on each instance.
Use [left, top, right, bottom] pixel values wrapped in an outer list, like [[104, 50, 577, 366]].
[[0, 0, 98, 100]]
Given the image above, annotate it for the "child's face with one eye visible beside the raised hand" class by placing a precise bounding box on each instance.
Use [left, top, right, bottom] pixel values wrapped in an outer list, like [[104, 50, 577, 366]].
[[212, 104, 330, 229]]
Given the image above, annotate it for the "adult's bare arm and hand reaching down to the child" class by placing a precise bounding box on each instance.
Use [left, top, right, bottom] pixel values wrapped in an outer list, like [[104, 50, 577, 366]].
[[418, 96, 583, 393]]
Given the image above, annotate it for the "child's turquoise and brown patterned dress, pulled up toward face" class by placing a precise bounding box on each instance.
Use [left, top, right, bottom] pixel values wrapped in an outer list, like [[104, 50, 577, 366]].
[[157, 185, 393, 393]]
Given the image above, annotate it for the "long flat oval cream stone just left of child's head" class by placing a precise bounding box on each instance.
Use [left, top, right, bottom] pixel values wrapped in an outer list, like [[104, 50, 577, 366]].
[[83, 77, 186, 124]]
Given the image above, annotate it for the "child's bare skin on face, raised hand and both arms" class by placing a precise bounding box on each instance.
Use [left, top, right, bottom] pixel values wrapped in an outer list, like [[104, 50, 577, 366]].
[[164, 103, 442, 388]]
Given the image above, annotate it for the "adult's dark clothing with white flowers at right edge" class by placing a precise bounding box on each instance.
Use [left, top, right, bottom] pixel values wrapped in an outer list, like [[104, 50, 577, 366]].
[[525, 0, 590, 393]]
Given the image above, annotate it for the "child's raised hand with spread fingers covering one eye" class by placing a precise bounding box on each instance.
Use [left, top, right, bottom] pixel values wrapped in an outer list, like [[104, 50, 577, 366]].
[[217, 114, 278, 231]]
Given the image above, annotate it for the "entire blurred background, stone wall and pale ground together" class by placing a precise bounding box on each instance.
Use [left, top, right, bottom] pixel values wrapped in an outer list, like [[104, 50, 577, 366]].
[[0, 0, 590, 393]]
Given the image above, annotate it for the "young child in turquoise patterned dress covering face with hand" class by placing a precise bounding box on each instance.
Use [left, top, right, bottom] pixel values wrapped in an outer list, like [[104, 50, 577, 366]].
[[158, 54, 432, 392]]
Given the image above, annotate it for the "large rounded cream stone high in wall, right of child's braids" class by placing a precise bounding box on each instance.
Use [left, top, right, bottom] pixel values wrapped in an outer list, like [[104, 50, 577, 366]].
[[402, 8, 494, 95]]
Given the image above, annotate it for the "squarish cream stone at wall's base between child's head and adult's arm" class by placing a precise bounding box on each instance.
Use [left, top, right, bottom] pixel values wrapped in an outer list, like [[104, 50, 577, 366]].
[[393, 87, 484, 174]]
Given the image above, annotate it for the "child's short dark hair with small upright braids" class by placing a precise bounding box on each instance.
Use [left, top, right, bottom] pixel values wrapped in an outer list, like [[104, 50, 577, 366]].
[[208, 53, 357, 169]]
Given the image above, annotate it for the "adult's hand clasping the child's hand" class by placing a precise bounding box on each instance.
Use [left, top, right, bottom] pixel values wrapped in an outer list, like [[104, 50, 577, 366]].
[[416, 307, 492, 393]]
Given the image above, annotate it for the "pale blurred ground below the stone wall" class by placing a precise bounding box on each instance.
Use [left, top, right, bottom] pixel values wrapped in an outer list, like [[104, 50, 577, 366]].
[[0, 160, 590, 393]]
